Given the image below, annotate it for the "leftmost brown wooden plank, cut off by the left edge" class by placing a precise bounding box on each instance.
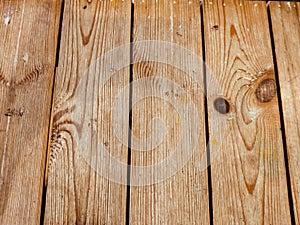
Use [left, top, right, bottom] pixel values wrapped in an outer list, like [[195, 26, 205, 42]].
[[0, 0, 61, 224]]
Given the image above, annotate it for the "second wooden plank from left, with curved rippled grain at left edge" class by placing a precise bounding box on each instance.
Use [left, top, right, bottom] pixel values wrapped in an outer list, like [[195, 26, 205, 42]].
[[45, 0, 131, 224]]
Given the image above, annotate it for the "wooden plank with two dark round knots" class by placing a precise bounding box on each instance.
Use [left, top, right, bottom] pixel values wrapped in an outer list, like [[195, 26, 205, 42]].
[[204, 0, 291, 224]]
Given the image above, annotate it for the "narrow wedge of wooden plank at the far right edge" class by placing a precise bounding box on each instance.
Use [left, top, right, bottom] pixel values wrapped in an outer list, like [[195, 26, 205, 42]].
[[270, 2, 300, 224]]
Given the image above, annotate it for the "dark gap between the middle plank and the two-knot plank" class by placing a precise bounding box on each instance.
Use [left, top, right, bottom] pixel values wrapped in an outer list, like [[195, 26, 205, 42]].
[[200, 2, 213, 225]]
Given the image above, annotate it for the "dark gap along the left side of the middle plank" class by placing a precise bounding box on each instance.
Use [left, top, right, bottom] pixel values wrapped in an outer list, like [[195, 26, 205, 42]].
[[126, 2, 134, 225]]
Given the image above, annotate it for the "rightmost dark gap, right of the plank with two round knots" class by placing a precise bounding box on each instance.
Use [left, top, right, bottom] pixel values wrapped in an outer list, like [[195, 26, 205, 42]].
[[267, 1, 296, 225]]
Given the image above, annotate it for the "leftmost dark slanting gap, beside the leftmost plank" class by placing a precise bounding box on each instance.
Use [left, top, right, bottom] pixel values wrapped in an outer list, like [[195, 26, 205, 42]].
[[40, 0, 65, 225]]
